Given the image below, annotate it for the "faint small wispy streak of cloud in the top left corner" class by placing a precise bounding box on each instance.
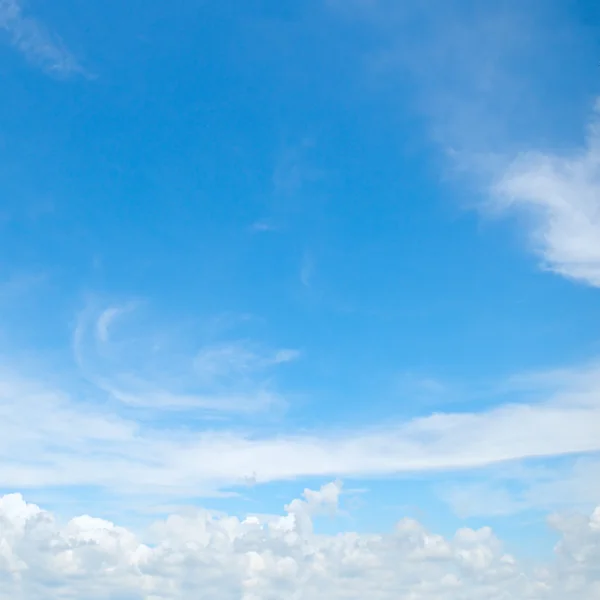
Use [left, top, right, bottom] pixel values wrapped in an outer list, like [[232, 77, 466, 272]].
[[0, 0, 83, 77]]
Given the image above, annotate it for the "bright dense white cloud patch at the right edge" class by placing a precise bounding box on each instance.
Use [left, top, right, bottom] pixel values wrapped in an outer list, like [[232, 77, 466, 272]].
[[493, 101, 600, 286]]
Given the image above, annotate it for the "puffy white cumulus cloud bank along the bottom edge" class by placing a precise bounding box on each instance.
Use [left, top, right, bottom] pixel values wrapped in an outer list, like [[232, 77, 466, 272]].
[[0, 484, 600, 600]]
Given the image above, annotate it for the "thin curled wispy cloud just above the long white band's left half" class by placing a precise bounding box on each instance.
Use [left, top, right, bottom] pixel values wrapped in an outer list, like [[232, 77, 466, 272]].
[[73, 303, 300, 414]]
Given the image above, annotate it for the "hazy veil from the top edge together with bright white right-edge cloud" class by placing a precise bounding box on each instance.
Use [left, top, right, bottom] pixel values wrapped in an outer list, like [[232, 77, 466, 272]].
[[331, 0, 600, 286]]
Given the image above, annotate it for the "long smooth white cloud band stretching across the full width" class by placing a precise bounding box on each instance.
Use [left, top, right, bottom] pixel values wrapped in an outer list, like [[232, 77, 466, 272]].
[[5, 356, 600, 502]]
